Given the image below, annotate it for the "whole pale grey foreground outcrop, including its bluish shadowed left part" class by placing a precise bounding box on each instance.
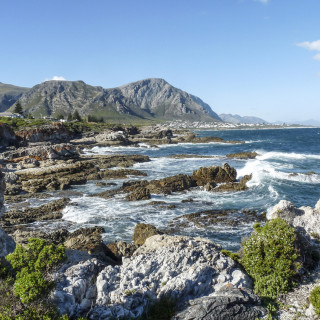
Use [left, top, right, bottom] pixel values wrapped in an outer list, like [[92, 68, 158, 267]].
[[51, 235, 266, 320]]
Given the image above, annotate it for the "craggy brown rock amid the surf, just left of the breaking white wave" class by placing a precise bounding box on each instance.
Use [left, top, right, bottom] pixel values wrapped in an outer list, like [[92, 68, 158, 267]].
[[192, 163, 237, 186]]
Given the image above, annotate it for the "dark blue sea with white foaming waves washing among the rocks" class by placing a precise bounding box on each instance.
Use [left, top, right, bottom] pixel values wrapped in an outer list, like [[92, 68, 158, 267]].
[[63, 128, 320, 250]]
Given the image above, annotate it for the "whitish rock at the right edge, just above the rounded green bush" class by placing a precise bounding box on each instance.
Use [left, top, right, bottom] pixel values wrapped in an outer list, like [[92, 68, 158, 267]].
[[267, 200, 320, 236]]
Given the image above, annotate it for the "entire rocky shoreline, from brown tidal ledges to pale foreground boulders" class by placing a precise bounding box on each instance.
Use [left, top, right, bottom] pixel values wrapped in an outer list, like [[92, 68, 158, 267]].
[[0, 124, 320, 320]]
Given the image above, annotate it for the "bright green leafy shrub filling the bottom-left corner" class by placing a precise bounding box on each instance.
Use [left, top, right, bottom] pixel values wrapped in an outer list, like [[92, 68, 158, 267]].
[[0, 239, 67, 320]]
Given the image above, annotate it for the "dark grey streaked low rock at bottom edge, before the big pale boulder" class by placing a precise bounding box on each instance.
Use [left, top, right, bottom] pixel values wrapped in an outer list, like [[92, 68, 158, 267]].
[[172, 285, 267, 320]]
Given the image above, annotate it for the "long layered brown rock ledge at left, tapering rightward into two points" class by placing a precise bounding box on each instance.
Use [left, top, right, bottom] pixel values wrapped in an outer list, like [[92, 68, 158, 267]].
[[8, 155, 149, 194]]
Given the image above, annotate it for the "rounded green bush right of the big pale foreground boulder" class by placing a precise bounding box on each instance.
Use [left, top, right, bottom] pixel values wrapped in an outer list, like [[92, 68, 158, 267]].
[[240, 218, 298, 298]]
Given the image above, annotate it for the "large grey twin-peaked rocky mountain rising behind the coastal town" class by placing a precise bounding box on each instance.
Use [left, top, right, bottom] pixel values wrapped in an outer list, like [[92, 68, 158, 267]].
[[10, 79, 221, 121]]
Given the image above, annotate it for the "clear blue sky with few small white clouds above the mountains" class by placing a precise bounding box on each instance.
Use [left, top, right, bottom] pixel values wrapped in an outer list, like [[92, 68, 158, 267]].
[[0, 0, 320, 121]]
